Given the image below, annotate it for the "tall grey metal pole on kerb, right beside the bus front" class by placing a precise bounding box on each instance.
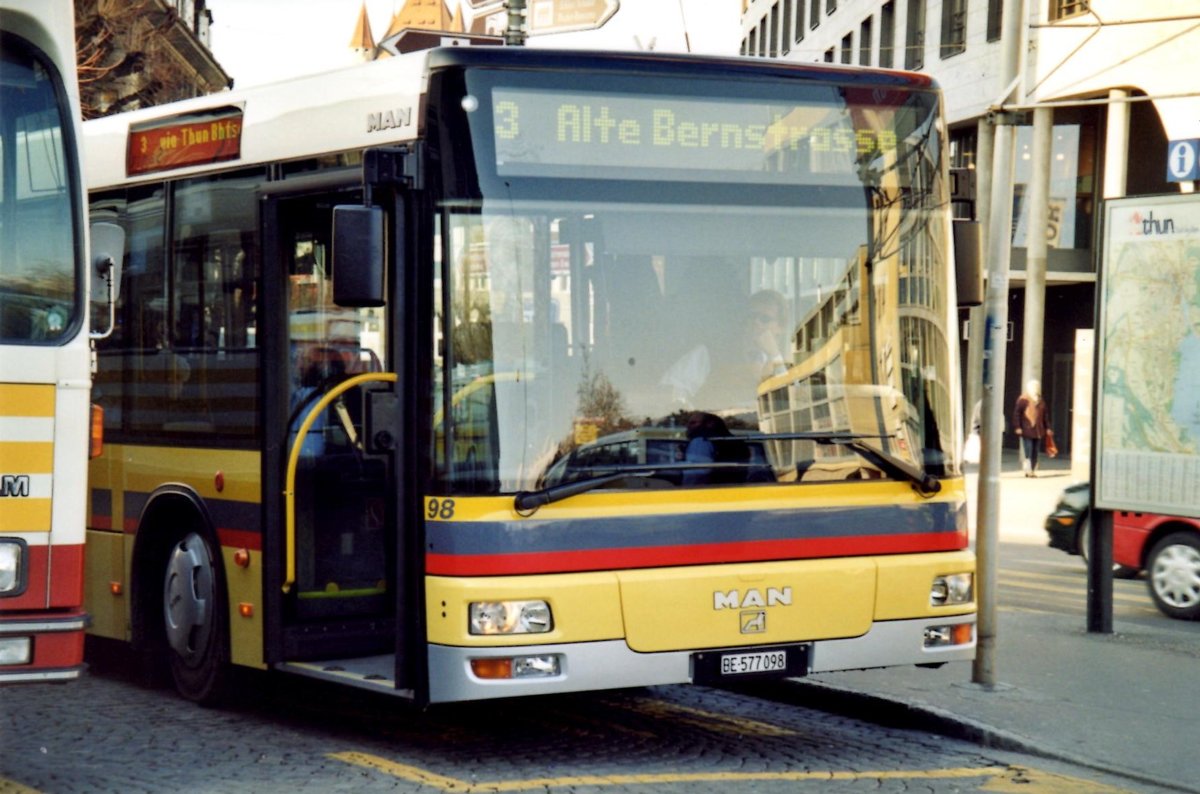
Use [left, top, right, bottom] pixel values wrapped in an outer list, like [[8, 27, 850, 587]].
[[971, 0, 1025, 686]]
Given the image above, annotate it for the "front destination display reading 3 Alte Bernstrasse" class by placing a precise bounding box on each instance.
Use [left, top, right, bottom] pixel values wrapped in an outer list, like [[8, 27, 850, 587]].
[[492, 88, 896, 184]]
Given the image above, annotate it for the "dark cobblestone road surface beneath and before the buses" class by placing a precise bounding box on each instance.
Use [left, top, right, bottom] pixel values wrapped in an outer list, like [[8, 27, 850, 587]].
[[0, 652, 1150, 794]]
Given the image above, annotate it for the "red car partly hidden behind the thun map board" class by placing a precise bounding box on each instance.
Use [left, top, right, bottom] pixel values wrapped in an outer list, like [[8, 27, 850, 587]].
[[1112, 511, 1200, 620]]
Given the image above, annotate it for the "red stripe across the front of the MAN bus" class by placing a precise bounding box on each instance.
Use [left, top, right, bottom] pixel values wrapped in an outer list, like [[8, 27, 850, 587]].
[[425, 530, 967, 576]]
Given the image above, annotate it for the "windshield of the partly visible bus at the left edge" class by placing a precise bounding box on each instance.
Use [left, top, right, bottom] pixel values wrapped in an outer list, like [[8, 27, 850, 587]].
[[0, 36, 79, 343]]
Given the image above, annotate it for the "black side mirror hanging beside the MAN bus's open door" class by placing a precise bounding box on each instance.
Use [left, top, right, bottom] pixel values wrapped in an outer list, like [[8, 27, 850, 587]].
[[334, 205, 385, 308]]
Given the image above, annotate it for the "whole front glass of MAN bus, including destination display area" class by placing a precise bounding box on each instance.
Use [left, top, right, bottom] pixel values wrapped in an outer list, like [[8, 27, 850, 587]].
[[433, 65, 958, 493]]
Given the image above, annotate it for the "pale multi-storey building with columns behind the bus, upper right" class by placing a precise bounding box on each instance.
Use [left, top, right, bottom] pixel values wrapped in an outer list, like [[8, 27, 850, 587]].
[[742, 0, 1200, 458]]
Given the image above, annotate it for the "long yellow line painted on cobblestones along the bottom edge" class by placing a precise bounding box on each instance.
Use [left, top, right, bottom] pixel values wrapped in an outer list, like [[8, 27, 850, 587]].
[[329, 751, 1124, 794]]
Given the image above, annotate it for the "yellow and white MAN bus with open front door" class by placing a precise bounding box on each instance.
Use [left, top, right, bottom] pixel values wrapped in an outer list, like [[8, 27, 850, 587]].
[[85, 47, 976, 705]]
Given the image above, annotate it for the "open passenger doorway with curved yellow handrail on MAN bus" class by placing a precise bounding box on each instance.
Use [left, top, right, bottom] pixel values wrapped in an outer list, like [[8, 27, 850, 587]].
[[262, 191, 396, 678]]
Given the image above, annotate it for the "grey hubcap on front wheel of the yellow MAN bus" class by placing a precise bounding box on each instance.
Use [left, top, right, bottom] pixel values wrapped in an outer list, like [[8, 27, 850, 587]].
[[163, 533, 214, 661]]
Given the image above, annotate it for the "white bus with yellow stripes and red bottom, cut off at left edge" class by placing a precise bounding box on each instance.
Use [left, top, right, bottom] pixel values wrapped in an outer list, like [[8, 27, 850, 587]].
[[0, 0, 91, 684]]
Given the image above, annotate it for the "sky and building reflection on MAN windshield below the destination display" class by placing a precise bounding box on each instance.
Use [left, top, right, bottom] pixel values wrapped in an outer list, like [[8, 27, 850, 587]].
[[436, 204, 950, 493]]
